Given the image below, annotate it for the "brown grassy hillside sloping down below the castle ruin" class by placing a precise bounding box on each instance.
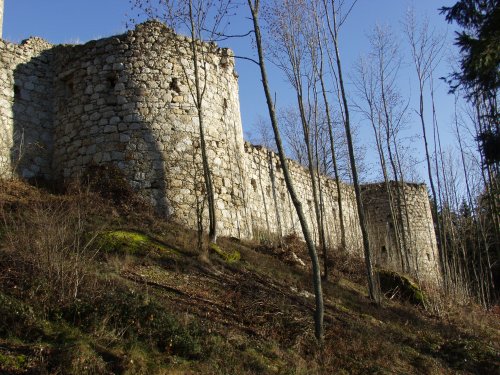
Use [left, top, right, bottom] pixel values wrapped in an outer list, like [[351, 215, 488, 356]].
[[0, 181, 500, 374]]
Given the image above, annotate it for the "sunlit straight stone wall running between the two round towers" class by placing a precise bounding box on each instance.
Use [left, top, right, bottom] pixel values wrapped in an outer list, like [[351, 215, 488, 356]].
[[245, 143, 361, 254]]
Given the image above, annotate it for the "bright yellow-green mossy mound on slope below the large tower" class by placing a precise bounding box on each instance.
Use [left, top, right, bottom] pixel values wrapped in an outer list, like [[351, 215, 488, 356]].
[[99, 230, 177, 255]]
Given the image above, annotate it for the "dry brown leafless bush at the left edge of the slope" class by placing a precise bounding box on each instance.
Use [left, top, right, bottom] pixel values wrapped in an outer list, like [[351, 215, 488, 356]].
[[0, 201, 104, 312]]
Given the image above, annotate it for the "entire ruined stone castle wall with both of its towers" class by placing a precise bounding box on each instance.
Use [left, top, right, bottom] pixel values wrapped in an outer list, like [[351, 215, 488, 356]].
[[0, 21, 440, 281]]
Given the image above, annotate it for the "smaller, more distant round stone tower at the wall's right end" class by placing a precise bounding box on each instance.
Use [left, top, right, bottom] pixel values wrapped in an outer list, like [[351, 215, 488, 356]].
[[362, 182, 441, 282]]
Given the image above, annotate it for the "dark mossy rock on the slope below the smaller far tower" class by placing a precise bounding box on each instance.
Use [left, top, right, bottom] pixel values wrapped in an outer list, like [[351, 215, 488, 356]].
[[377, 270, 427, 306]]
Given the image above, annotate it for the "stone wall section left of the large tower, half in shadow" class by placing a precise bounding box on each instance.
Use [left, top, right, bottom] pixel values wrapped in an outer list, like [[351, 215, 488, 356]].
[[0, 38, 53, 178]]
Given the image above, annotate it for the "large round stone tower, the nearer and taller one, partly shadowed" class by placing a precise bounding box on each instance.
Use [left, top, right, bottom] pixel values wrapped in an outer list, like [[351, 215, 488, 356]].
[[49, 22, 249, 236]]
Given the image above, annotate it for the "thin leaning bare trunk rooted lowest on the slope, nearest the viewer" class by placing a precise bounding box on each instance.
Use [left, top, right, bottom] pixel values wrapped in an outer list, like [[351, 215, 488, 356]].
[[247, 0, 324, 342]]
